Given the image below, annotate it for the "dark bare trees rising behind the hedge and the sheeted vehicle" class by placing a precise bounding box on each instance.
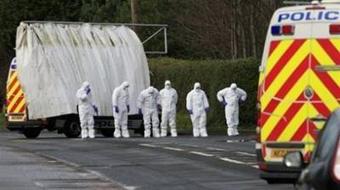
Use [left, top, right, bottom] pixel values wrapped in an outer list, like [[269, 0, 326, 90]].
[[0, 0, 290, 106]]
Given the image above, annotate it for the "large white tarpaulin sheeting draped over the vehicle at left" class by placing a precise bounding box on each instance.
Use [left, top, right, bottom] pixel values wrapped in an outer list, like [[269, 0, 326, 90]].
[[16, 22, 150, 119]]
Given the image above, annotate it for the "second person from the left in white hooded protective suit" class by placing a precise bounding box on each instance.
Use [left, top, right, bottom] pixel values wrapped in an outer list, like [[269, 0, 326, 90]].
[[112, 82, 130, 138]]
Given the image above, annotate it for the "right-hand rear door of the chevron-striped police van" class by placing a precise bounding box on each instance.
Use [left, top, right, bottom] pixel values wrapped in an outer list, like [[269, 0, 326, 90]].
[[307, 4, 340, 154]]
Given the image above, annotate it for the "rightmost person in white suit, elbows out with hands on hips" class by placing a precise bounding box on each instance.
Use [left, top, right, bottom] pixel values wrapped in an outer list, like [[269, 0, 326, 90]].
[[217, 83, 247, 136]]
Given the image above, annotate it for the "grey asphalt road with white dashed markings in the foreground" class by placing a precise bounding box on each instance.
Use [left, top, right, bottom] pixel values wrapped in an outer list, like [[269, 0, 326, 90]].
[[0, 132, 294, 190]]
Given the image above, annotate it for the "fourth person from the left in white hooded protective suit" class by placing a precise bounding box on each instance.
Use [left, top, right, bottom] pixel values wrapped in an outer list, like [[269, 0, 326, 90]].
[[160, 80, 178, 137]]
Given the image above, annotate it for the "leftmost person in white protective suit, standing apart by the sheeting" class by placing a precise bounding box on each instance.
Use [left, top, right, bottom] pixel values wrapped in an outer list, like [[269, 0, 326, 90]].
[[76, 81, 98, 139]]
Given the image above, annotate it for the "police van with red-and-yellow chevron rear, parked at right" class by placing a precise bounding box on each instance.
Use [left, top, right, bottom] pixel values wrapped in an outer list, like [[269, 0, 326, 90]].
[[256, 0, 340, 183]]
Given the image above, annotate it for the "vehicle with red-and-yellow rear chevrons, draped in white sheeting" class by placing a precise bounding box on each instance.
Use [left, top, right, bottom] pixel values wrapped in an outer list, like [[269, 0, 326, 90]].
[[6, 21, 150, 138]]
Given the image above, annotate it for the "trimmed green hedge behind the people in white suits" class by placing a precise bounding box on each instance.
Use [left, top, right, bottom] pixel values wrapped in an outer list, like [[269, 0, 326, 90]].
[[149, 58, 259, 128]]
